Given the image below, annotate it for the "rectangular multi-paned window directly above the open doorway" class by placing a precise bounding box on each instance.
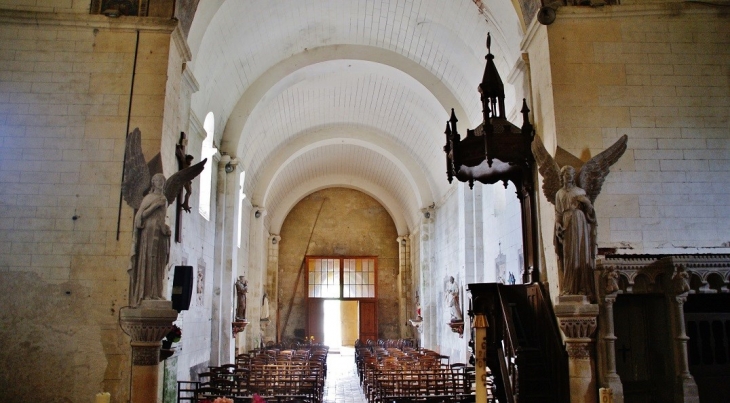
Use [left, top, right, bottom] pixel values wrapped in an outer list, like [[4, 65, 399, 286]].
[[307, 257, 377, 298]]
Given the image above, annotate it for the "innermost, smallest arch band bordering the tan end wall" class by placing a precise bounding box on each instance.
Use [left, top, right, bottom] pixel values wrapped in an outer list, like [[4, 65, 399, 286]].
[[265, 175, 415, 236]]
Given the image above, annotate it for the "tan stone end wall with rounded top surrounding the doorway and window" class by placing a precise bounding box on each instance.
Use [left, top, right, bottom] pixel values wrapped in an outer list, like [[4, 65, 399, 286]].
[[272, 188, 404, 339]]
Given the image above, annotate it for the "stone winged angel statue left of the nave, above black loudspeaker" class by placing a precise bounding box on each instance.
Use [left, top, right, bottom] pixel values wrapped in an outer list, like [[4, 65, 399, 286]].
[[122, 128, 207, 307]]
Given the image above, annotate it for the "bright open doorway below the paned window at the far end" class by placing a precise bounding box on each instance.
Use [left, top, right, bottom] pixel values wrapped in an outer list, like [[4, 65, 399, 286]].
[[322, 299, 360, 351]]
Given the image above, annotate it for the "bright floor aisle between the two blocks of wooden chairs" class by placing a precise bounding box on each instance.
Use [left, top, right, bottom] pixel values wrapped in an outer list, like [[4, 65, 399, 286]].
[[323, 347, 367, 403]]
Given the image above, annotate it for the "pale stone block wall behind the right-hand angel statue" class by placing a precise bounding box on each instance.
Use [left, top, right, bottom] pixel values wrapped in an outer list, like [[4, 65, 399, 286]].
[[524, 4, 730, 295]]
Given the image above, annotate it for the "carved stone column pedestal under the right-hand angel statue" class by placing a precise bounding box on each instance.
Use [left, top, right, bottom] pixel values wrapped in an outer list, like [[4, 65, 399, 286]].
[[555, 295, 598, 403]]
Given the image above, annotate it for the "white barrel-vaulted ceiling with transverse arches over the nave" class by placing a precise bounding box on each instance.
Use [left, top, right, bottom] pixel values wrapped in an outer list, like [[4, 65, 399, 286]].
[[188, 0, 523, 234]]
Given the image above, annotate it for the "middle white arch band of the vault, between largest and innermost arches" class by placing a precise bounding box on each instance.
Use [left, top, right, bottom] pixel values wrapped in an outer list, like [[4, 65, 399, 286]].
[[251, 125, 434, 208]]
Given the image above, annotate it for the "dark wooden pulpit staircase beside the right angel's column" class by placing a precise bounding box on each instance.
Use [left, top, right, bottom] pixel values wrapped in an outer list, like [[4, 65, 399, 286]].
[[469, 283, 570, 403]]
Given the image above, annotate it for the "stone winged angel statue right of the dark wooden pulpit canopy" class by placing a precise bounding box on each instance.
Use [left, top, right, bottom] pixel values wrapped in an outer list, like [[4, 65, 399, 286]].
[[532, 135, 628, 300]]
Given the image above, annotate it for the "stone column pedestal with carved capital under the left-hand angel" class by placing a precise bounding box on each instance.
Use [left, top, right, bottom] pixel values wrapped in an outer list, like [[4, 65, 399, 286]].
[[120, 300, 177, 403]]
